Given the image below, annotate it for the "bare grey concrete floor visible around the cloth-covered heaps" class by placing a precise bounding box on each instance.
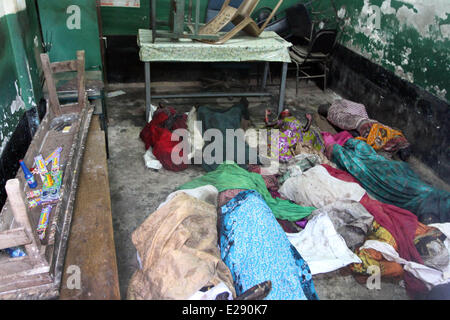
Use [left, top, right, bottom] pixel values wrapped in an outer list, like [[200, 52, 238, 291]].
[[107, 81, 408, 300]]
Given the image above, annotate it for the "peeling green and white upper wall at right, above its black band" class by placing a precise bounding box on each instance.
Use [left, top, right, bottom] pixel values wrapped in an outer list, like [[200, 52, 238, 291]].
[[316, 0, 450, 101]]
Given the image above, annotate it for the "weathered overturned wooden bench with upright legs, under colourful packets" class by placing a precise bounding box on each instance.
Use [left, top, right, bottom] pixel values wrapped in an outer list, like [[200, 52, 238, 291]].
[[0, 51, 93, 299]]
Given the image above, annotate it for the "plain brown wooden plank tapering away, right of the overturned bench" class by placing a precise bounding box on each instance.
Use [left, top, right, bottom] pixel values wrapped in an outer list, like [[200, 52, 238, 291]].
[[60, 116, 120, 300]]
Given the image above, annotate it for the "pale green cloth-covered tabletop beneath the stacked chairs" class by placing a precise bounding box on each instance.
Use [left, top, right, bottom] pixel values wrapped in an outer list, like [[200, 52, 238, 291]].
[[138, 29, 292, 62]]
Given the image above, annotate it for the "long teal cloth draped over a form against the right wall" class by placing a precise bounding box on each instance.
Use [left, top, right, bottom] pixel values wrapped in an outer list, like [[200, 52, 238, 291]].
[[333, 139, 450, 224]]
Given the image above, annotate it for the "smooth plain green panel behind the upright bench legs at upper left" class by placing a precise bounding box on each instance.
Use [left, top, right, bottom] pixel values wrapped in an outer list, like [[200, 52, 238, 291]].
[[38, 0, 102, 70]]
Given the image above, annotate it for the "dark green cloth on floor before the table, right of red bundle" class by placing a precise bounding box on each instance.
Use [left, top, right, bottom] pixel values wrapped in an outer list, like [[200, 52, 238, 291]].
[[197, 103, 258, 172]]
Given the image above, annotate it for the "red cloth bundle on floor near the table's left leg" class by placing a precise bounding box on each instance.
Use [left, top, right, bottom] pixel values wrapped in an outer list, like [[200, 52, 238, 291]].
[[139, 107, 187, 171]]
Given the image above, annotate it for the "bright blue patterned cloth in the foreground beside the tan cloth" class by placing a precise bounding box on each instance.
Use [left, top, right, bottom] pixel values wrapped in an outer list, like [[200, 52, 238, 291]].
[[219, 190, 319, 300]]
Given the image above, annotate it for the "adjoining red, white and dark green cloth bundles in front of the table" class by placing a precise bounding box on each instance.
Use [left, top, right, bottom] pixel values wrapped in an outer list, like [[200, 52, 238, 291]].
[[140, 99, 255, 171]]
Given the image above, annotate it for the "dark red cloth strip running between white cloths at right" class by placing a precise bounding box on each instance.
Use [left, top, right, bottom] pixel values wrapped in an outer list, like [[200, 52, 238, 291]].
[[323, 164, 427, 296]]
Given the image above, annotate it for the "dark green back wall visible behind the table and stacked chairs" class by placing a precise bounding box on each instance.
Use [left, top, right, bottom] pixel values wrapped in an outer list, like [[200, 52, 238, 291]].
[[101, 0, 298, 36]]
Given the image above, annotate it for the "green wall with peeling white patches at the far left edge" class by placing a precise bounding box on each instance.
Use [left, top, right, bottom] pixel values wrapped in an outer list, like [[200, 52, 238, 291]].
[[0, 0, 42, 155]]
